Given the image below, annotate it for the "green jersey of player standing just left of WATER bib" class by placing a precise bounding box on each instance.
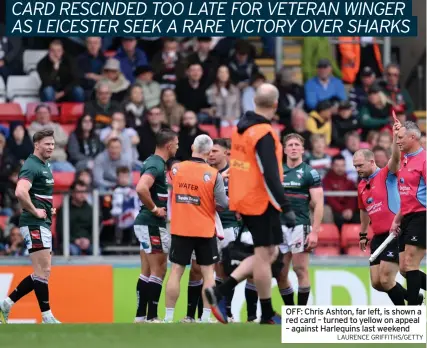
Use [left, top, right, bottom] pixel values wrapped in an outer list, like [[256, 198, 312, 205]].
[[135, 155, 168, 228]]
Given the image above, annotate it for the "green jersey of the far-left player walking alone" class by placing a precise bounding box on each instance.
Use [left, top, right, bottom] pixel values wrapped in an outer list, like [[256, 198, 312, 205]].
[[19, 154, 54, 229]]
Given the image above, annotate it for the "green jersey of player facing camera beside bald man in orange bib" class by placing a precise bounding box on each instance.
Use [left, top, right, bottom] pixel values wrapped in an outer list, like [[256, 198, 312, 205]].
[[282, 162, 322, 226]]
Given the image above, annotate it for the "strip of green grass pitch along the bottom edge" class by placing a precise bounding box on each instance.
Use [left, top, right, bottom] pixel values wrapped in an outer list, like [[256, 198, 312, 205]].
[[0, 324, 425, 348]]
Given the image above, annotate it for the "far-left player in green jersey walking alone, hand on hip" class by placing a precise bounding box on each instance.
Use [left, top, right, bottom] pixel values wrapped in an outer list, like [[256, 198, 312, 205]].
[[0, 130, 60, 324]]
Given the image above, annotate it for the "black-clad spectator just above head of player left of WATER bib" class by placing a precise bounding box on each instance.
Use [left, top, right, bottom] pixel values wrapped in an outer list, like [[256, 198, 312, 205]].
[[137, 106, 169, 161]]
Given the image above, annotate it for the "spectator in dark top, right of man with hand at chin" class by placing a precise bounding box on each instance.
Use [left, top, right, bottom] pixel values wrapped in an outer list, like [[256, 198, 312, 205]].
[[77, 36, 106, 100]]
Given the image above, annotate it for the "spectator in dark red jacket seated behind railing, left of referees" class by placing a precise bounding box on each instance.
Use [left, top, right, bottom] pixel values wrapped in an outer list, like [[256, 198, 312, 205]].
[[323, 155, 360, 230]]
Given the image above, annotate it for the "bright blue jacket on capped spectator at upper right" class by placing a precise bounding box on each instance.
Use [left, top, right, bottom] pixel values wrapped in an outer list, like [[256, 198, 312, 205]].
[[304, 76, 347, 110]]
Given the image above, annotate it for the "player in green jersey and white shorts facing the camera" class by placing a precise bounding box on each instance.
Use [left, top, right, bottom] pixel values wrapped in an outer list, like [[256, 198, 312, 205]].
[[278, 133, 323, 306]]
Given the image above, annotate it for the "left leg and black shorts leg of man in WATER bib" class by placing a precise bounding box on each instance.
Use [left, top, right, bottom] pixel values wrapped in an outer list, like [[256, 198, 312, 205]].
[[165, 235, 194, 322]]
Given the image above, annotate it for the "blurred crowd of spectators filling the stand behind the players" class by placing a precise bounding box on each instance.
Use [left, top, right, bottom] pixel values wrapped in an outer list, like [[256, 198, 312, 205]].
[[0, 37, 426, 256]]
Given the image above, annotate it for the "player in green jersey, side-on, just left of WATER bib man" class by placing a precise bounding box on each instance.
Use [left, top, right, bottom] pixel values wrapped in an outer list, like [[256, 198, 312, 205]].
[[134, 130, 178, 322]]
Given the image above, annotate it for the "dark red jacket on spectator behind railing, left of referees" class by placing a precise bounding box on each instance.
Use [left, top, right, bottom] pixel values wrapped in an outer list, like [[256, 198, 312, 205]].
[[323, 170, 357, 213]]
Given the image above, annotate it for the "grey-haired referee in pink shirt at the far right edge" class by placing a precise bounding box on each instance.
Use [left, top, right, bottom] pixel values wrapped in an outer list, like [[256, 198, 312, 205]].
[[391, 121, 426, 306]]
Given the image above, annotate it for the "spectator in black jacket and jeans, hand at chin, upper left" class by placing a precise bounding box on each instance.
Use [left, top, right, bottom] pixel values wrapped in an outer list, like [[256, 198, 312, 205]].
[[37, 40, 85, 102]]
